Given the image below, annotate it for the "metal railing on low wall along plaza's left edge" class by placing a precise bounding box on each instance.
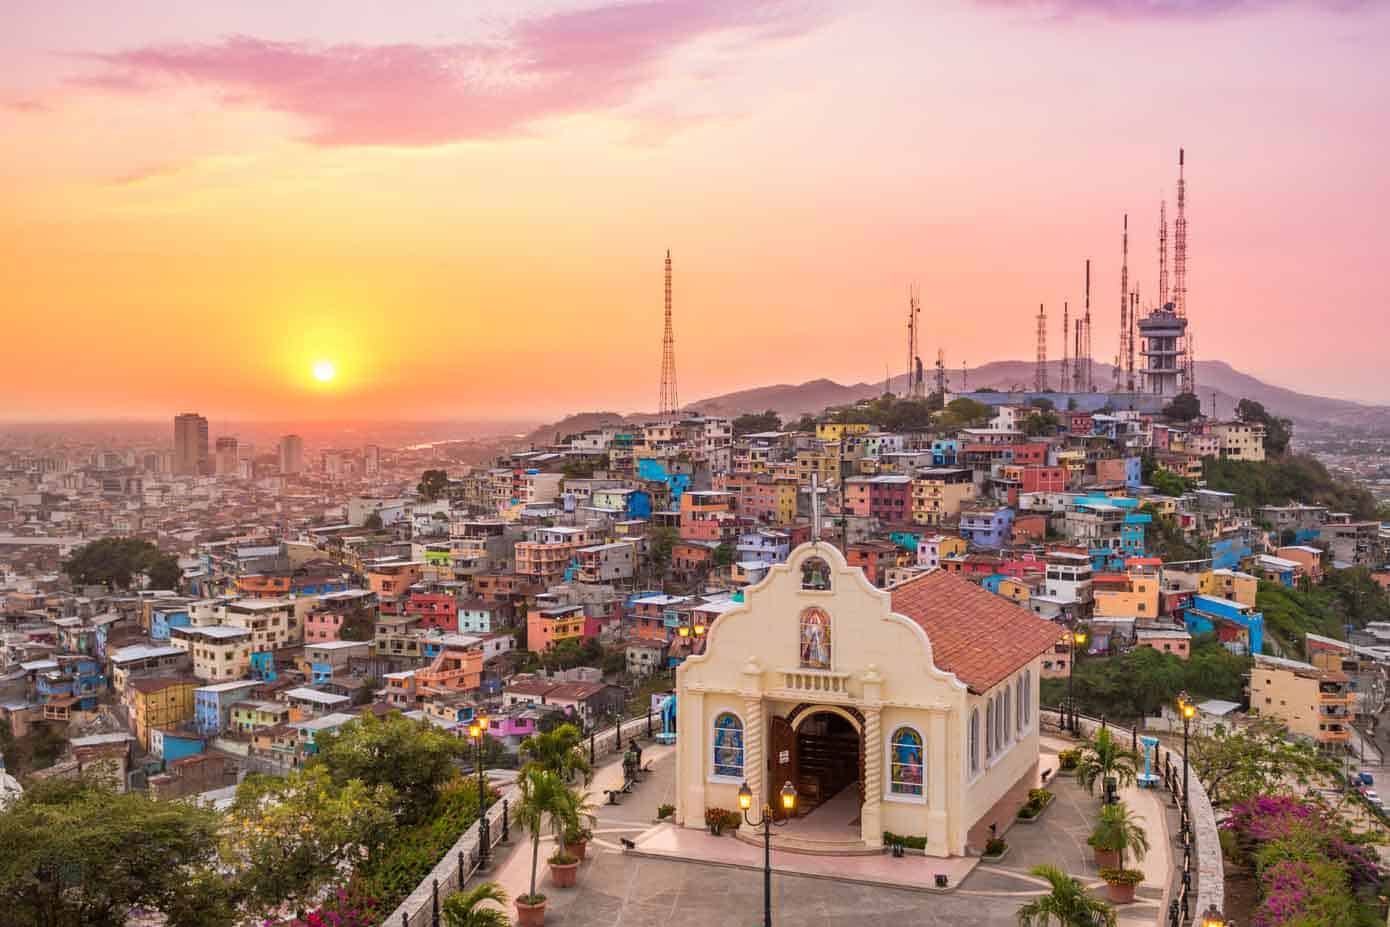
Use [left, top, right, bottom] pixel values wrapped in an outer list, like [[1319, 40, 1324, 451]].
[[381, 712, 660, 927]]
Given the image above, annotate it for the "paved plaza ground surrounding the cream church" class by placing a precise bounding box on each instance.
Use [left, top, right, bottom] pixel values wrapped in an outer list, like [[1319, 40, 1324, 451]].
[[478, 744, 1172, 927]]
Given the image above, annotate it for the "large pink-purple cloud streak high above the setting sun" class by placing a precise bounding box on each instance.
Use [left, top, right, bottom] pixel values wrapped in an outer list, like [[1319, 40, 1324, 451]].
[[65, 0, 817, 146]]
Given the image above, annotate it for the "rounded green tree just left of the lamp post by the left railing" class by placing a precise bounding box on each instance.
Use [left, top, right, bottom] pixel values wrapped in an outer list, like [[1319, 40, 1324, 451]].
[[313, 712, 470, 824]]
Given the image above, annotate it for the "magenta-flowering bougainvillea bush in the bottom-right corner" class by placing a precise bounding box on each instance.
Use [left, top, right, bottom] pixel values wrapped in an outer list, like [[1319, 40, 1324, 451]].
[[1222, 796, 1384, 927]]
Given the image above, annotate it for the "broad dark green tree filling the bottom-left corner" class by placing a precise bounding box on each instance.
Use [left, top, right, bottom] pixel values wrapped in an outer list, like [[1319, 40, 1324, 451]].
[[0, 780, 232, 927]]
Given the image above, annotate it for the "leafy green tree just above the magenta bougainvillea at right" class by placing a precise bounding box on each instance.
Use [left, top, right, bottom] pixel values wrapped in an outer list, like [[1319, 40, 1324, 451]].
[[1188, 717, 1337, 805]]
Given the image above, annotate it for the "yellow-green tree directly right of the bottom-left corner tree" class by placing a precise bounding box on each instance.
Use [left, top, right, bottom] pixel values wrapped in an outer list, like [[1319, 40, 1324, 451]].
[[222, 757, 396, 912]]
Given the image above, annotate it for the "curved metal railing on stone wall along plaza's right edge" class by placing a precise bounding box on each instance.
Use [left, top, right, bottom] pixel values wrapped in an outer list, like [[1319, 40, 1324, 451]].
[[1038, 707, 1226, 927]]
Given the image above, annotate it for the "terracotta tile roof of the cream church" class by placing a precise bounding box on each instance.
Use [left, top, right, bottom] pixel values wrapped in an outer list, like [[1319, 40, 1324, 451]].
[[892, 570, 1061, 694]]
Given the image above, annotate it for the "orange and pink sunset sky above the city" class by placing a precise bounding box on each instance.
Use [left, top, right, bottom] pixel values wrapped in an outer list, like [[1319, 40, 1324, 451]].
[[0, 0, 1390, 420]]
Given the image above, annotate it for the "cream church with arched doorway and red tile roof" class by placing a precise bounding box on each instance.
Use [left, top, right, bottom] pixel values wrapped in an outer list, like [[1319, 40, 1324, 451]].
[[676, 543, 1061, 856]]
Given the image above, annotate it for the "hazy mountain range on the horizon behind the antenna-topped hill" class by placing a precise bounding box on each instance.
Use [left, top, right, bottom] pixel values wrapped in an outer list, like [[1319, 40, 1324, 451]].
[[527, 360, 1390, 445]]
